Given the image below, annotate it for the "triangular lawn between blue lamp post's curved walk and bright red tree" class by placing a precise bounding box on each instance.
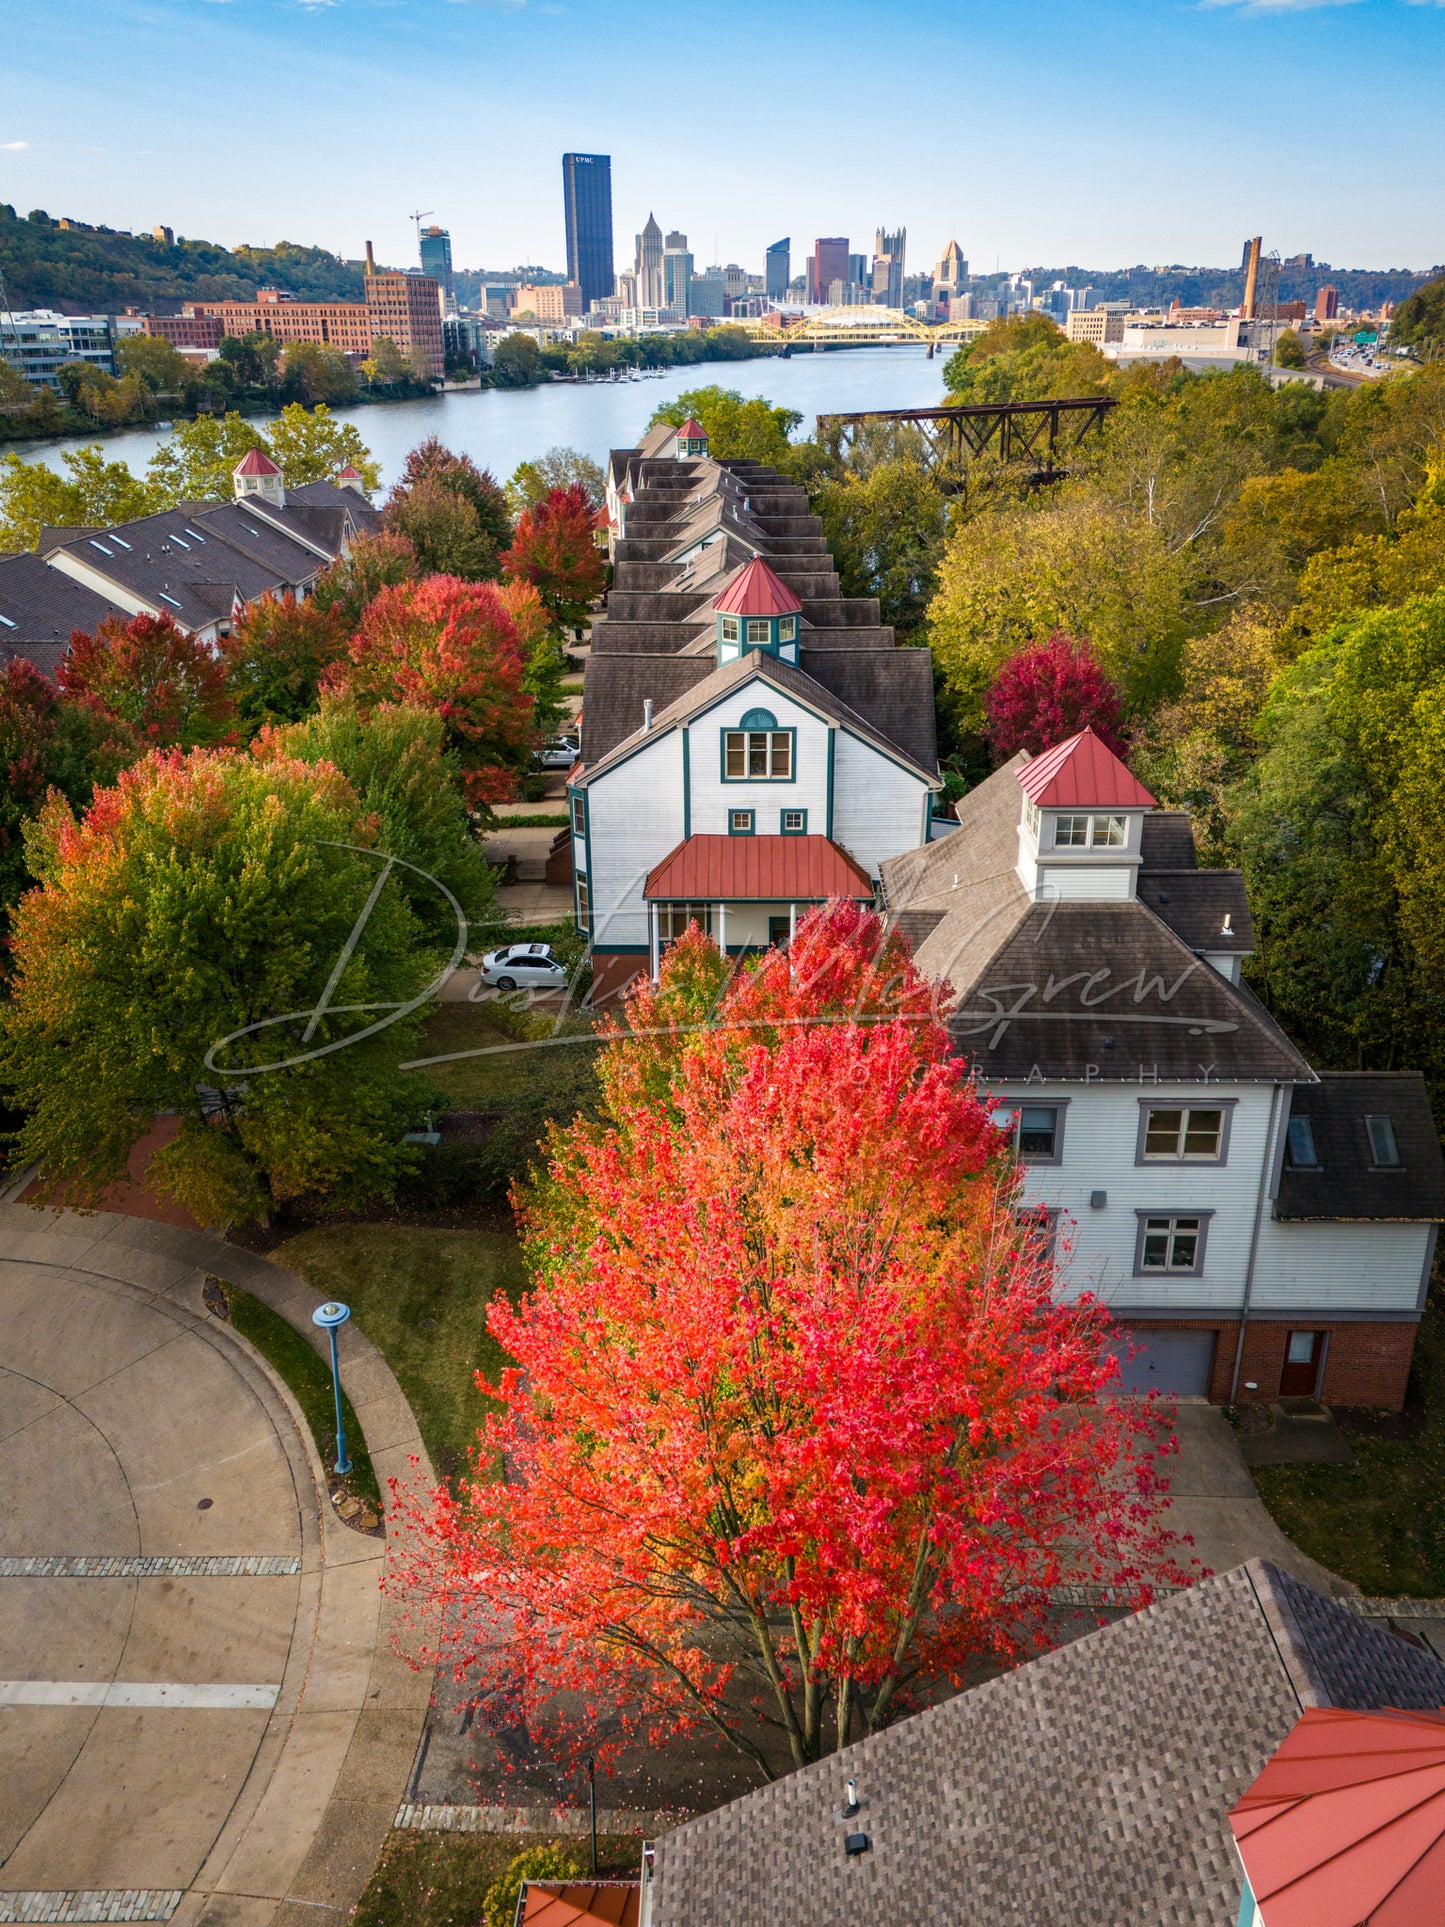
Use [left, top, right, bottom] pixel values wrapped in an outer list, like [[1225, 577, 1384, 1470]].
[[272, 1224, 526, 1478]]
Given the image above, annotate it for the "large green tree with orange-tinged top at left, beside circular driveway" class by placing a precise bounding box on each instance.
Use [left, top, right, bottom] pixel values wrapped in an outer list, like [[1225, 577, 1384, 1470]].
[[0, 750, 437, 1224]]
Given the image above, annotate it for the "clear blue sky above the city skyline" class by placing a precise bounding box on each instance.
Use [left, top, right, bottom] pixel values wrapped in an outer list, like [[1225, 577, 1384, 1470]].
[[0, 0, 1445, 281]]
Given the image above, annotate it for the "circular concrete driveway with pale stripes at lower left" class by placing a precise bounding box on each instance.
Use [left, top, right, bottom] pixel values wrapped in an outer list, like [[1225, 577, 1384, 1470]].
[[0, 1206, 428, 1927]]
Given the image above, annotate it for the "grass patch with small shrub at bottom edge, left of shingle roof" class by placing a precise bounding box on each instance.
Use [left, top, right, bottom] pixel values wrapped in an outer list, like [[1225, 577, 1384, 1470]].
[[351, 1829, 642, 1927]]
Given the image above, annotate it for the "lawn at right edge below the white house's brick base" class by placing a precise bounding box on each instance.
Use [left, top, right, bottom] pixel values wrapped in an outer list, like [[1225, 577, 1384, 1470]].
[[1254, 1297, 1445, 1599]]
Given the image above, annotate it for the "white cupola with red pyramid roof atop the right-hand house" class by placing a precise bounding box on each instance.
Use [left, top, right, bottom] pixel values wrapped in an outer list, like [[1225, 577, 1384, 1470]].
[[1017, 728, 1154, 902]]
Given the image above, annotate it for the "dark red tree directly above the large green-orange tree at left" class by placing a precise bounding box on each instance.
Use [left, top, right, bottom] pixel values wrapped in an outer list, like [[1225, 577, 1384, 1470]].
[[58, 615, 235, 750]]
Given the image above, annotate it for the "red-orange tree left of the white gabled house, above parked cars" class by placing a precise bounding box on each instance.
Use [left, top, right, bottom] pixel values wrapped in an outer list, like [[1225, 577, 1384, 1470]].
[[322, 576, 536, 807]]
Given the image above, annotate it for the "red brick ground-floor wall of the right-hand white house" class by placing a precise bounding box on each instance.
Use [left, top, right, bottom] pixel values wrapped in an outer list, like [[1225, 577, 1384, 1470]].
[[1119, 1318, 1418, 1412]]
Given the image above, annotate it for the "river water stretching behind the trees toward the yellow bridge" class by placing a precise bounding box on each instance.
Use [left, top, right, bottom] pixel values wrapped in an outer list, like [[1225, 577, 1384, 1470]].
[[17, 347, 944, 486]]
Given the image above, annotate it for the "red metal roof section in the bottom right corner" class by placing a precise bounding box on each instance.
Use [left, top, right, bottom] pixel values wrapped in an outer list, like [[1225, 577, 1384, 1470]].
[[1229, 1707, 1445, 1927]]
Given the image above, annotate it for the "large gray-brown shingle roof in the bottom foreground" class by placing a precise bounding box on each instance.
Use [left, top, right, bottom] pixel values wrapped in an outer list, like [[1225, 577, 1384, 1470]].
[[651, 1561, 1445, 1927]]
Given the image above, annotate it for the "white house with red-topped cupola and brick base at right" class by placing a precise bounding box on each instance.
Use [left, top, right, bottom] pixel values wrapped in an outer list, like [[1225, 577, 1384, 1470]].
[[882, 730, 1445, 1407]]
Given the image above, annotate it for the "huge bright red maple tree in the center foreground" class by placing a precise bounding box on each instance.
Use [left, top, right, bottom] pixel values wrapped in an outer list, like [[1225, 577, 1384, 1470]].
[[391, 906, 1181, 1777]]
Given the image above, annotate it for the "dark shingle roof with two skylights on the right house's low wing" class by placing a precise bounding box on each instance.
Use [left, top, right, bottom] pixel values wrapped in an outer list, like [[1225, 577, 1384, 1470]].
[[1275, 1071, 1445, 1224]]
